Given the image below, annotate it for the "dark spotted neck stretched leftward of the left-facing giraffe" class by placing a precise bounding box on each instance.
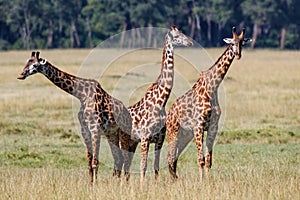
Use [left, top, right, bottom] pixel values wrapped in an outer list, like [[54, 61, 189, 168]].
[[39, 62, 88, 100]]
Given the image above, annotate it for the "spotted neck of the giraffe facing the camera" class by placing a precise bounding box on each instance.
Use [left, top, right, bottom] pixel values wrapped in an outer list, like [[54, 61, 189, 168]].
[[205, 45, 234, 91]]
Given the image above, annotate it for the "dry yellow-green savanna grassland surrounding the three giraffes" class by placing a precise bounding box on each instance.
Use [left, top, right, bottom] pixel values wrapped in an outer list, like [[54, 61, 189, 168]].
[[0, 48, 300, 199]]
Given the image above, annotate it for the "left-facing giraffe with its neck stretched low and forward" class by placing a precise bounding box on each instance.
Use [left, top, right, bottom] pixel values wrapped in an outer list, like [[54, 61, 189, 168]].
[[17, 52, 131, 183]]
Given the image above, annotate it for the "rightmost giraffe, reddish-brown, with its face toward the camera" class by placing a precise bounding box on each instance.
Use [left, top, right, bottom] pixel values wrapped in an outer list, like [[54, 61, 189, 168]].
[[166, 27, 251, 182]]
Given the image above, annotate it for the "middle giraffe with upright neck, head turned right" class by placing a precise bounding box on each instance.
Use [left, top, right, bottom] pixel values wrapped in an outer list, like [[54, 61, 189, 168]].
[[120, 26, 193, 183]]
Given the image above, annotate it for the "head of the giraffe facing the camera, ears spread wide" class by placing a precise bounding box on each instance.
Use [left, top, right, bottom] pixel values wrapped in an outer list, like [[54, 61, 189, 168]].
[[223, 27, 252, 59]]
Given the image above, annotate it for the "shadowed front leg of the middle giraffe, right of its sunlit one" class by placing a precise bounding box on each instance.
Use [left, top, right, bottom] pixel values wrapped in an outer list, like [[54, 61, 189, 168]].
[[154, 127, 166, 180]]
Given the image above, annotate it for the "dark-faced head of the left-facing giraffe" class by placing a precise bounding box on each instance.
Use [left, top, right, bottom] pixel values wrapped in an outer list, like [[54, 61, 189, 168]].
[[17, 51, 47, 80]]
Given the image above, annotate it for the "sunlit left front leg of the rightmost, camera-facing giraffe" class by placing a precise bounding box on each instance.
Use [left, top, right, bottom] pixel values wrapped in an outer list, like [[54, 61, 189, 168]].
[[194, 126, 204, 182]]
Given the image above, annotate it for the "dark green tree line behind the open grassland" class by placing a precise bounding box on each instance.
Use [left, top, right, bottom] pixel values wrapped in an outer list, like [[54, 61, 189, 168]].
[[0, 0, 300, 50]]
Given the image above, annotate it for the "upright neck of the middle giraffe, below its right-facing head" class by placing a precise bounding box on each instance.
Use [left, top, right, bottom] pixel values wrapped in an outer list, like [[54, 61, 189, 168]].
[[156, 33, 174, 89]]
